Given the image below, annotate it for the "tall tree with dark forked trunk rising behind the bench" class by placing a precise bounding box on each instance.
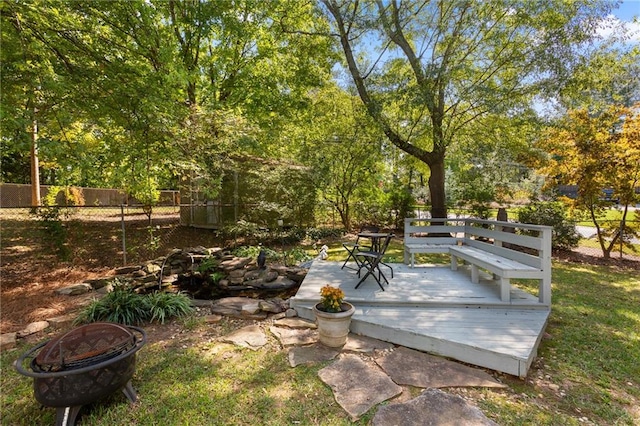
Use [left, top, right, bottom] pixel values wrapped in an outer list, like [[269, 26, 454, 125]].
[[322, 0, 613, 217]]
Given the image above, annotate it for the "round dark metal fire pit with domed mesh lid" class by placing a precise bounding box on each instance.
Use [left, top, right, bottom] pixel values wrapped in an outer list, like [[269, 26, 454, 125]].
[[14, 322, 146, 425]]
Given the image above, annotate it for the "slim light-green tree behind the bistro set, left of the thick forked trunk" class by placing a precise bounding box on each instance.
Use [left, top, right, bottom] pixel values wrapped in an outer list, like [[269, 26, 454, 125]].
[[289, 86, 385, 230]]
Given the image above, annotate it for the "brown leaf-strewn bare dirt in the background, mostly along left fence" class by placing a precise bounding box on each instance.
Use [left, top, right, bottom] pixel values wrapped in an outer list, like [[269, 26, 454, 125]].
[[0, 219, 640, 333]]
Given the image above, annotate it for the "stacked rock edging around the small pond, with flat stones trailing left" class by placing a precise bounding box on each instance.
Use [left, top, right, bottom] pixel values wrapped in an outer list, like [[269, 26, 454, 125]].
[[0, 247, 308, 351]]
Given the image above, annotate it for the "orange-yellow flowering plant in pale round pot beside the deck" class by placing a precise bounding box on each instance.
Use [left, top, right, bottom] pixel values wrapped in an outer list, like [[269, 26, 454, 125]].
[[313, 284, 356, 348]]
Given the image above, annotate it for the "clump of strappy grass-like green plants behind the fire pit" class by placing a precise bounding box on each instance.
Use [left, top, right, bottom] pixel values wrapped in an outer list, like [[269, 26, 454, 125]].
[[75, 279, 193, 325]]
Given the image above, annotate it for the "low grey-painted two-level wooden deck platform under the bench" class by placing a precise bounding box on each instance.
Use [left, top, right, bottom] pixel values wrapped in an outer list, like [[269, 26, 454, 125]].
[[291, 261, 550, 377]]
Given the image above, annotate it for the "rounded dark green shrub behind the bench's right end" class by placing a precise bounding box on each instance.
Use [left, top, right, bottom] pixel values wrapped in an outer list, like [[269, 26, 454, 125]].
[[518, 201, 580, 250]]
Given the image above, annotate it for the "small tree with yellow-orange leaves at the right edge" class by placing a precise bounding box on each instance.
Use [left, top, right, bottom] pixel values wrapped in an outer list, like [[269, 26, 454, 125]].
[[539, 104, 640, 258]]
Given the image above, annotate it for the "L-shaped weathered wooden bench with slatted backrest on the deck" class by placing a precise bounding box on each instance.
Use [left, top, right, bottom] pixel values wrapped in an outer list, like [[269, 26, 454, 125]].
[[405, 219, 551, 306]]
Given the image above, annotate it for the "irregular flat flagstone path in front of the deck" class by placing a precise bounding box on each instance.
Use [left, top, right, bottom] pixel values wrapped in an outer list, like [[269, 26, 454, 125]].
[[223, 318, 506, 426]]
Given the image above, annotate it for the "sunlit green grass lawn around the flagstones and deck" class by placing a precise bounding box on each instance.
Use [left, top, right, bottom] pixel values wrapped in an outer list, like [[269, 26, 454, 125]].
[[0, 242, 640, 426]]
